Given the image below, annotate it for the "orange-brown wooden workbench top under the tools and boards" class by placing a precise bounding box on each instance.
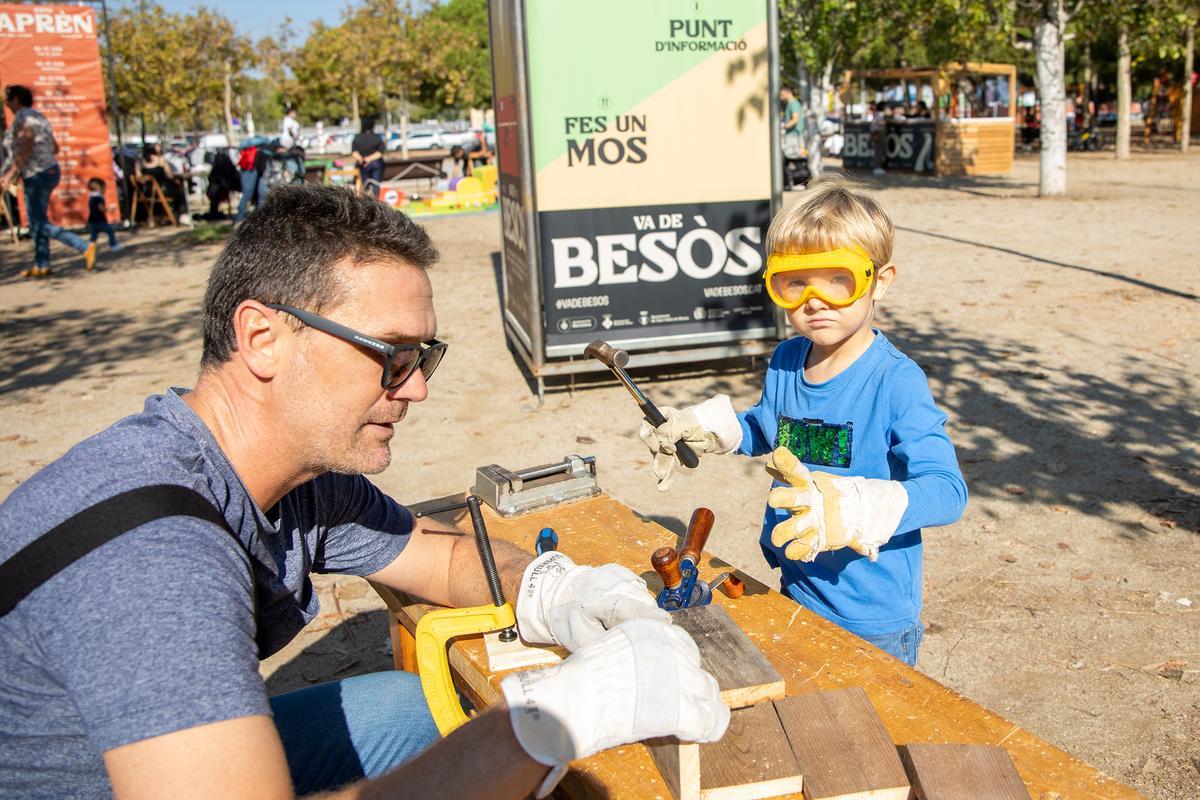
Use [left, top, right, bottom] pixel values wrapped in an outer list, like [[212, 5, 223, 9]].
[[377, 495, 1141, 800]]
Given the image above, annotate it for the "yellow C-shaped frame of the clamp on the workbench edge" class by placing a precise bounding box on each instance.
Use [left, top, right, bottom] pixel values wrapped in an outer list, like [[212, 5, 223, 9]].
[[415, 603, 516, 736]]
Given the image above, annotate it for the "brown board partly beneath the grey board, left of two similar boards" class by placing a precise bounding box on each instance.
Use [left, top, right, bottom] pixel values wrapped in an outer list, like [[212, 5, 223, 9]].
[[700, 703, 804, 800]]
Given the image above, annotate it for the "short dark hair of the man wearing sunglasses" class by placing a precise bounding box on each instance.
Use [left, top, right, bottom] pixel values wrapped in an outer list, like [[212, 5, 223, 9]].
[[200, 184, 438, 367]]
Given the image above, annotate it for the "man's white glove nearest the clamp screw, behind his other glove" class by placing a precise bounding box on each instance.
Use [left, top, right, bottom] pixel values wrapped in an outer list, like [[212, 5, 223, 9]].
[[517, 551, 671, 652]]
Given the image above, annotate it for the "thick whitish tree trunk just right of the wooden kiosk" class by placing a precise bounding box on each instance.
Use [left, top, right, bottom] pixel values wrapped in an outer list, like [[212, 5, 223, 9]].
[[1034, 0, 1067, 197]]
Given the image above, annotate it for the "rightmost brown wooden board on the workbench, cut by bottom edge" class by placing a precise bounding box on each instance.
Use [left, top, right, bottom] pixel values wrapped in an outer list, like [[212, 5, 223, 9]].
[[900, 744, 1030, 800]]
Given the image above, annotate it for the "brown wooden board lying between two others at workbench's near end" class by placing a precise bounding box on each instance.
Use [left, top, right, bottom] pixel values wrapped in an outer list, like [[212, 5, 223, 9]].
[[775, 686, 910, 800]]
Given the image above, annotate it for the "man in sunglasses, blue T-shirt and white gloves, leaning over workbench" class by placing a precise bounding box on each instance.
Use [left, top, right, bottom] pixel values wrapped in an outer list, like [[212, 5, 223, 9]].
[[0, 186, 728, 800]]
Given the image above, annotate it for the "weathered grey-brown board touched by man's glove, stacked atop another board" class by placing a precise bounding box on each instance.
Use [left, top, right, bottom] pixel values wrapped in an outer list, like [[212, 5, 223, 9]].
[[672, 606, 785, 709]]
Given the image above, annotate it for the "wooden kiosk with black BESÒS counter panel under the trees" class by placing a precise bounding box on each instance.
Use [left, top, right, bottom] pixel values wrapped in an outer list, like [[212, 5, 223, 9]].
[[842, 62, 1018, 175]]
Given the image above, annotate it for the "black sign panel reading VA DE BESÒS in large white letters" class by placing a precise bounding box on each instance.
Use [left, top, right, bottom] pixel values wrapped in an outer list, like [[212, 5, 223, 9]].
[[538, 200, 774, 349]]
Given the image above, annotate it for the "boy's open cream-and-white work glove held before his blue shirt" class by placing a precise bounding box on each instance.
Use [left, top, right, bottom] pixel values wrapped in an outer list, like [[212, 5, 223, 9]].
[[767, 447, 908, 561]]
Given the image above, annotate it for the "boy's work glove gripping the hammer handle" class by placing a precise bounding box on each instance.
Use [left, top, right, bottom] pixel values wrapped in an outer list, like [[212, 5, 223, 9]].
[[638, 395, 742, 492]]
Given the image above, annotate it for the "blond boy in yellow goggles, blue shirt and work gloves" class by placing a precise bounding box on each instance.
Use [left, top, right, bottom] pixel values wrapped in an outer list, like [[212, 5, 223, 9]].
[[642, 179, 967, 666]]
